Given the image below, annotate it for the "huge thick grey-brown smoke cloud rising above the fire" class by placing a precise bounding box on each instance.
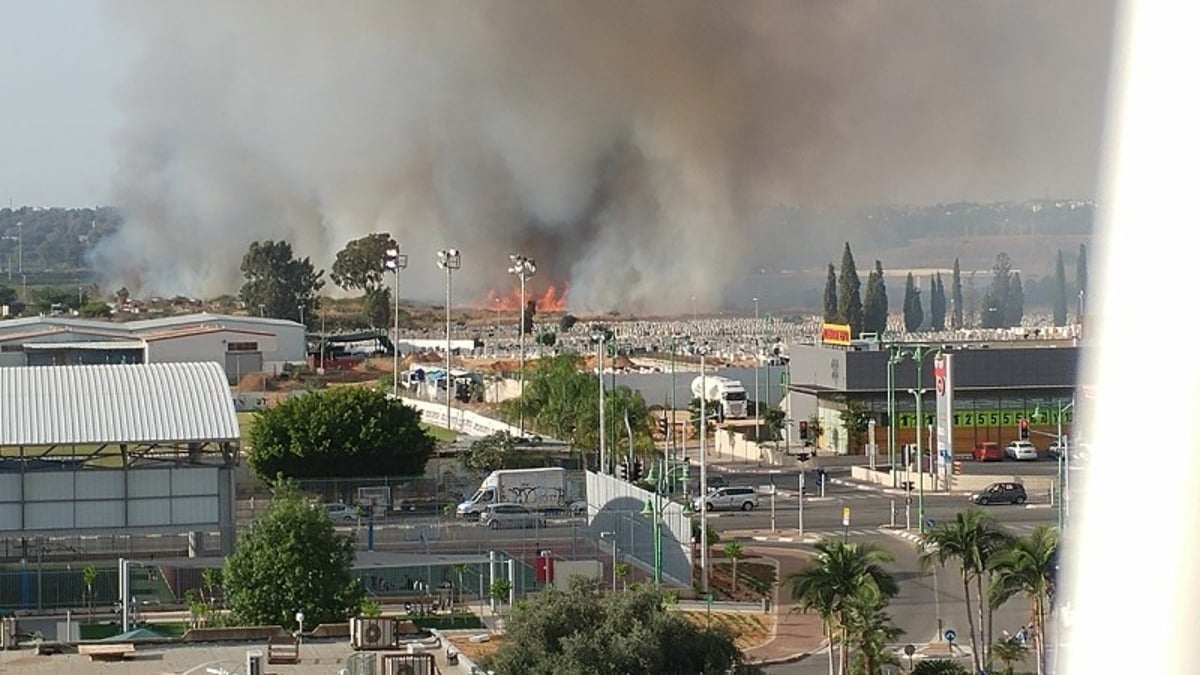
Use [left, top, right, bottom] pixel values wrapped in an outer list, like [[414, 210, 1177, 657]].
[[95, 0, 1111, 311]]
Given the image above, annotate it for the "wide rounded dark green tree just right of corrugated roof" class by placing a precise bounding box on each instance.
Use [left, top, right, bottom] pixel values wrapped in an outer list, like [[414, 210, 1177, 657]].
[[248, 387, 434, 478]]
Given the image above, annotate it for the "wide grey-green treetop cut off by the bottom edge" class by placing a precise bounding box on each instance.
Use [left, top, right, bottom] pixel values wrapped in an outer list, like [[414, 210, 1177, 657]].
[[480, 579, 761, 675]]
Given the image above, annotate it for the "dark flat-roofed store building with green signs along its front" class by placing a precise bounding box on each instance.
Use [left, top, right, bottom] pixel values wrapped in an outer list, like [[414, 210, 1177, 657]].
[[787, 340, 1081, 454]]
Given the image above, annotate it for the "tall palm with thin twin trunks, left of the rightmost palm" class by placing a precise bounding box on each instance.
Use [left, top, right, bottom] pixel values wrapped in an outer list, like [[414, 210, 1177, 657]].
[[920, 508, 1009, 673]]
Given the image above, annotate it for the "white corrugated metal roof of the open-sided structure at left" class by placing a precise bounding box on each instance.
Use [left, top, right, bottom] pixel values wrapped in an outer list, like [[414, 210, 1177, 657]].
[[0, 363, 240, 447]]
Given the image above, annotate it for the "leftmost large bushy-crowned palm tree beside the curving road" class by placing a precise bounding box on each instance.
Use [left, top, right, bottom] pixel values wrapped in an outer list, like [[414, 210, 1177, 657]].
[[787, 539, 899, 674]]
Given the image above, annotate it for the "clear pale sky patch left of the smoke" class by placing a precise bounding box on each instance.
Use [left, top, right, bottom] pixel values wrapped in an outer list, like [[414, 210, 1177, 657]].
[[0, 0, 132, 207]]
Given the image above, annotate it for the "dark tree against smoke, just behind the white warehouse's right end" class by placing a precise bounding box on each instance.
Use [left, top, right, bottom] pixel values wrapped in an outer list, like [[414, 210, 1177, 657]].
[[239, 240, 325, 323]]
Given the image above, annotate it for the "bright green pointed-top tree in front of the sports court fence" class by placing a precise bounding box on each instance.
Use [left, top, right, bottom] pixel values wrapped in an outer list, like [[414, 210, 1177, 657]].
[[224, 480, 364, 626]]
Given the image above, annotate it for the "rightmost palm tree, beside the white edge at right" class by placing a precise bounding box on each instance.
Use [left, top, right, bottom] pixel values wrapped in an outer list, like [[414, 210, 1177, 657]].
[[989, 525, 1058, 675]]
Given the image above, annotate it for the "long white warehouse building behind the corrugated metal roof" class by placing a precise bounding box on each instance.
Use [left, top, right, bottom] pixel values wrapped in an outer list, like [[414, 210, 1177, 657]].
[[0, 313, 307, 382]]
